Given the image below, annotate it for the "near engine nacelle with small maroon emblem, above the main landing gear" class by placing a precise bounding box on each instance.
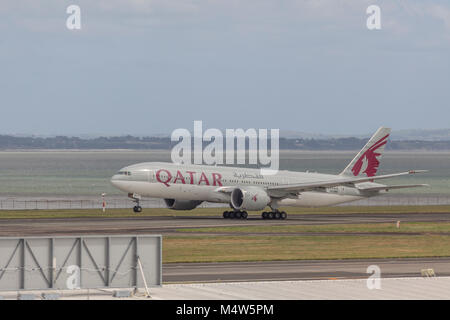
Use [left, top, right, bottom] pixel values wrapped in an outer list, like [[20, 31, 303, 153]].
[[231, 187, 270, 210]]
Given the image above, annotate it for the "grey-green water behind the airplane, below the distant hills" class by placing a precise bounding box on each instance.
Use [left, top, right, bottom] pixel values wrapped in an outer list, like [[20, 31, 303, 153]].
[[0, 150, 450, 196]]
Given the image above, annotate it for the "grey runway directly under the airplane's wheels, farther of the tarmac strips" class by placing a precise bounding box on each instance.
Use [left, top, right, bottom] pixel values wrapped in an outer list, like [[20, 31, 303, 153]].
[[0, 213, 450, 236]]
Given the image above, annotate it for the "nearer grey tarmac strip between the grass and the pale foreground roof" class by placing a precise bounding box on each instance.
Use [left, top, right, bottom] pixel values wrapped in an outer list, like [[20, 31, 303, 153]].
[[163, 258, 450, 283]]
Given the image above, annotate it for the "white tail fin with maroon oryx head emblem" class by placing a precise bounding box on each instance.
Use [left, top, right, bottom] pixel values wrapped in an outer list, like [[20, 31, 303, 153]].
[[340, 127, 391, 177]]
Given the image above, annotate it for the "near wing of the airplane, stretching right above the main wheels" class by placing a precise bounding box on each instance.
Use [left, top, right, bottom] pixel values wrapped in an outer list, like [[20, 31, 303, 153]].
[[267, 170, 428, 193]]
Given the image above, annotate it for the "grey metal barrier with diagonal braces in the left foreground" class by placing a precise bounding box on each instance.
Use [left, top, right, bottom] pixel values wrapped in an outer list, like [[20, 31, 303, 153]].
[[0, 235, 162, 291]]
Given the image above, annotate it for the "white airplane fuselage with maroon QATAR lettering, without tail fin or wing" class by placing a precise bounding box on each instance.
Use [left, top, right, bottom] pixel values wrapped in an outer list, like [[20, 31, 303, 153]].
[[111, 162, 380, 207]]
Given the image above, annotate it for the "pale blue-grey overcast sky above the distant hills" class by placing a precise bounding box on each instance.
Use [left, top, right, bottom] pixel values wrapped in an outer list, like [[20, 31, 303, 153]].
[[0, 0, 450, 135]]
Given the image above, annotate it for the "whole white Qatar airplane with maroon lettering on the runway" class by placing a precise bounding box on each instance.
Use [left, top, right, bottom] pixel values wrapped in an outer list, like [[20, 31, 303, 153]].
[[111, 127, 428, 220]]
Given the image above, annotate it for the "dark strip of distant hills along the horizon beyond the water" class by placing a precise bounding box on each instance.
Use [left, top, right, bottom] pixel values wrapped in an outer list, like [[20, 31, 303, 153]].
[[0, 135, 450, 151]]
